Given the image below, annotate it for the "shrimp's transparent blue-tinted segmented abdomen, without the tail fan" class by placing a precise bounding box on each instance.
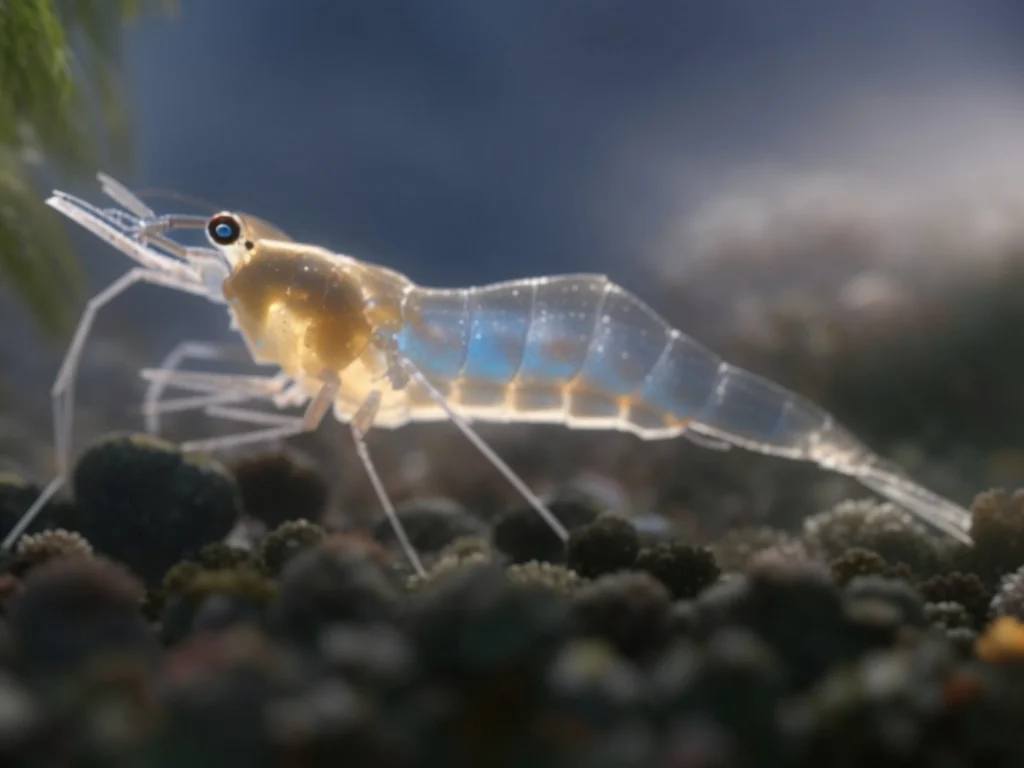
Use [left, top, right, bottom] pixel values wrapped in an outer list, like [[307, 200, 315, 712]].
[[397, 274, 862, 464]]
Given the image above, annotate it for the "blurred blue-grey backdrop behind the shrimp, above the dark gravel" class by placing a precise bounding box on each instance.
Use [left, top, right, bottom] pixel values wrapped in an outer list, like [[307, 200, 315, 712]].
[[6, 0, 1024, 525]]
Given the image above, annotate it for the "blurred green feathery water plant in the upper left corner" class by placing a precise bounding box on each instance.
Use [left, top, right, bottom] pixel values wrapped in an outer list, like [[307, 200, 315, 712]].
[[0, 0, 176, 334]]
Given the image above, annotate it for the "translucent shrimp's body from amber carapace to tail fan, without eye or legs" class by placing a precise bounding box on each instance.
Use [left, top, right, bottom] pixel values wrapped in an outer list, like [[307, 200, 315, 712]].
[[224, 231, 969, 540]]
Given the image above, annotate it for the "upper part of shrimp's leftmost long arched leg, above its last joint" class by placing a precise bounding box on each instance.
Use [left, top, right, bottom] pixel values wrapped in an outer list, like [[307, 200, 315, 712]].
[[50, 267, 211, 475]]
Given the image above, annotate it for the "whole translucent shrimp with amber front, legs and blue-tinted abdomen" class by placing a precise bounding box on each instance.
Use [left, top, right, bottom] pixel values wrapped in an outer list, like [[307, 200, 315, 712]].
[[6, 176, 970, 569]]
